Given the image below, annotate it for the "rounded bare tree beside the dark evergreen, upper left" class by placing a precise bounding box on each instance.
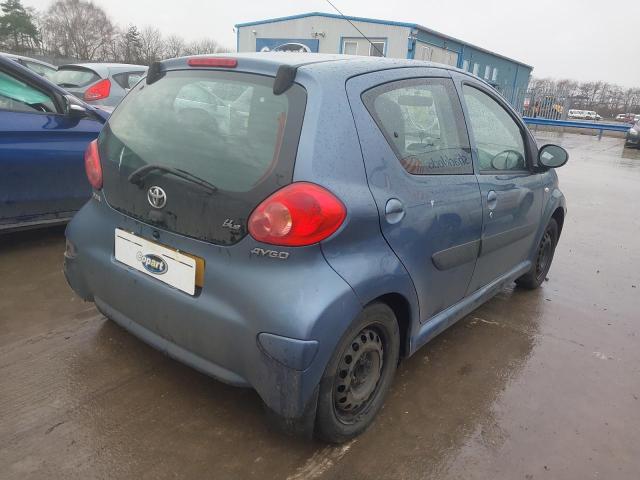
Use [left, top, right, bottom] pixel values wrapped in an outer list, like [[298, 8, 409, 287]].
[[43, 0, 114, 60]]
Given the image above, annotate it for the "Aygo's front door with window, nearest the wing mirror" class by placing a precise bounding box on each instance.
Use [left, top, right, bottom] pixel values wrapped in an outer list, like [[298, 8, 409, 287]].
[[462, 83, 543, 293]]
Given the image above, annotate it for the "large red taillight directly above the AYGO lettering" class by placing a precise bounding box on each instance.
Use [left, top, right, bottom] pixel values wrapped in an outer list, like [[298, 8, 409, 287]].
[[249, 182, 347, 247]]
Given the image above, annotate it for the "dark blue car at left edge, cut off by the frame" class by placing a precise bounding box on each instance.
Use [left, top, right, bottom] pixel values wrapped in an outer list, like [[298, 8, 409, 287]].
[[0, 56, 108, 232]]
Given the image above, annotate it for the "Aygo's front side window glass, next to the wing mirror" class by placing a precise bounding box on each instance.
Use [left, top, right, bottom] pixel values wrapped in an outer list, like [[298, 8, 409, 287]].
[[463, 85, 527, 171]]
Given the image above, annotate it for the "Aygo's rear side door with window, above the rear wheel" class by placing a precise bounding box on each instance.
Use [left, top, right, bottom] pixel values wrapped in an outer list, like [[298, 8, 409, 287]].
[[347, 68, 482, 321]]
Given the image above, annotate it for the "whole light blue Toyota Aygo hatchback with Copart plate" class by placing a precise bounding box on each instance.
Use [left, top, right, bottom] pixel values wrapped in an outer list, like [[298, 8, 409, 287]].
[[65, 53, 568, 442]]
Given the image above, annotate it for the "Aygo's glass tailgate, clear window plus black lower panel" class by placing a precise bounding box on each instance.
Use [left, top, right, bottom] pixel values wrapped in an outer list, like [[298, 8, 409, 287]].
[[99, 70, 306, 244]]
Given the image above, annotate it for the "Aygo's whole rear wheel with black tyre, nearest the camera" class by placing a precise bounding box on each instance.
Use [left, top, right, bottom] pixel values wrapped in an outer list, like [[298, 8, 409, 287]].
[[316, 303, 400, 443]]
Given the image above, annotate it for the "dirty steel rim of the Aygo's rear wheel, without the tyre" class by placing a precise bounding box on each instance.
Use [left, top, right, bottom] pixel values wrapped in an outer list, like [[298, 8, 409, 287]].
[[333, 327, 384, 423]]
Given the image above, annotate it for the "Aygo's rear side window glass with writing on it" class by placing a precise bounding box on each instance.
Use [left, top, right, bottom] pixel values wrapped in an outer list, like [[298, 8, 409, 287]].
[[362, 78, 473, 175]]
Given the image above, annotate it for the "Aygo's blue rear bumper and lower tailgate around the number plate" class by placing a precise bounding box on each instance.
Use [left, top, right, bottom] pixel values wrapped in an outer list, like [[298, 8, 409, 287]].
[[64, 200, 362, 419]]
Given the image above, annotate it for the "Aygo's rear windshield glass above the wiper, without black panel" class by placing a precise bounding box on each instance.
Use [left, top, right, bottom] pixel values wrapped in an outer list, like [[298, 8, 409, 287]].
[[105, 71, 304, 192]]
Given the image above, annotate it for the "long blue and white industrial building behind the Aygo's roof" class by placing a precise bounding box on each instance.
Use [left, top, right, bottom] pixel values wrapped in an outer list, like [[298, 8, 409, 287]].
[[236, 12, 533, 106]]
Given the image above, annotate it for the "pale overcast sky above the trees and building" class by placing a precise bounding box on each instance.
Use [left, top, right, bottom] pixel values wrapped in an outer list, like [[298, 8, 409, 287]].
[[23, 0, 640, 87]]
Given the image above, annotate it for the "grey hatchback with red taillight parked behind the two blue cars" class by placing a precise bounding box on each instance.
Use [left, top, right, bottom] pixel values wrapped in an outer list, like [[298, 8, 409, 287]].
[[53, 63, 147, 107]]
